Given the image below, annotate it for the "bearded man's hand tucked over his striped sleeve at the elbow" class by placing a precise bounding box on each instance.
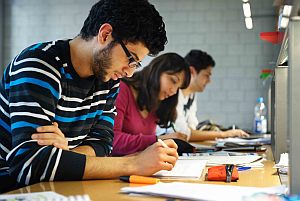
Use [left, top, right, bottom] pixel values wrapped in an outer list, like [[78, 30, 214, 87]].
[[31, 122, 69, 150]]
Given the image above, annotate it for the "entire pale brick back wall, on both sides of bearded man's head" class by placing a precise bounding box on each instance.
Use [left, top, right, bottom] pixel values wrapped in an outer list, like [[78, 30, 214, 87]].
[[5, 0, 278, 128]]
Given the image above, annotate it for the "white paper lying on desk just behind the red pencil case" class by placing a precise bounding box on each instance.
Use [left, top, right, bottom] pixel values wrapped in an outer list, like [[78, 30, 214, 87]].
[[179, 155, 262, 166]]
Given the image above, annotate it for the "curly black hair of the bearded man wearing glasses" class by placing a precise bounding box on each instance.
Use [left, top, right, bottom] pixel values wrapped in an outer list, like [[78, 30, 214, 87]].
[[79, 0, 167, 56]]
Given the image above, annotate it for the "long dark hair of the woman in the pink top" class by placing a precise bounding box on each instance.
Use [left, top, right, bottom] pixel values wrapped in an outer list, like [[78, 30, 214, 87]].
[[123, 53, 191, 127]]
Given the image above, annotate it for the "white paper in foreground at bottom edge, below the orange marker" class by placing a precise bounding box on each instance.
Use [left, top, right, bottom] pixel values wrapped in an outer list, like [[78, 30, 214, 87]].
[[121, 182, 286, 201]]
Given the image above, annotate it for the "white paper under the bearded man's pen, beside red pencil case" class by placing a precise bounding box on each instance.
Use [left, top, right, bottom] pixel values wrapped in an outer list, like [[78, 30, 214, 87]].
[[153, 159, 206, 179]]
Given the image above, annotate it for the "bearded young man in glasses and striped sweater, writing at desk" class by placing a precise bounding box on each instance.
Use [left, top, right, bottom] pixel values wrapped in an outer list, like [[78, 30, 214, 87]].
[[0, 0, 178, 192]]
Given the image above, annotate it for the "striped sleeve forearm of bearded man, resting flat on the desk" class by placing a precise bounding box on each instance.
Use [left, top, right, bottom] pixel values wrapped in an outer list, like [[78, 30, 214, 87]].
[[6, 140, 86, 185]]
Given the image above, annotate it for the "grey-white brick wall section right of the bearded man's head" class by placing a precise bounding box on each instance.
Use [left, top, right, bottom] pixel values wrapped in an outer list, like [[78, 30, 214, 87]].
[[151, 0, 278, 129]]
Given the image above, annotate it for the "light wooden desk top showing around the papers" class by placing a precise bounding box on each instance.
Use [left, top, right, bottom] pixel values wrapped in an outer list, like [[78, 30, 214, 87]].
[[9, 147, 281, 201]]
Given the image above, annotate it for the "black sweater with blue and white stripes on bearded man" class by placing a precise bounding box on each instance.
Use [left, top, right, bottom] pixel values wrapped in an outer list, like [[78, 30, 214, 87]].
[[0, 41, 119, 190]]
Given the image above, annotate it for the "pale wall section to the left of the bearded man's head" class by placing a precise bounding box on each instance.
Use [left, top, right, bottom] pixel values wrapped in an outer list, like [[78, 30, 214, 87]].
[[5, 0, 96, 63]]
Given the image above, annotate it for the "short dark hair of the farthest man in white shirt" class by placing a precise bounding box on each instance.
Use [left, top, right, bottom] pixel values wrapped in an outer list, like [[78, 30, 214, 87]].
[[184, 50, 216, 73]]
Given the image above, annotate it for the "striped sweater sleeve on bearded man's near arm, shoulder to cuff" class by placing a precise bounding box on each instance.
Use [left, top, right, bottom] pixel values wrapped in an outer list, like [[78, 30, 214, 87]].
[[5, 50, 86, 185]]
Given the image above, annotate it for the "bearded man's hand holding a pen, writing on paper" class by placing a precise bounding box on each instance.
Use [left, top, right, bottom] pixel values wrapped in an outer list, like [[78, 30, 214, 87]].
[[134, 140, 178, 176]]
